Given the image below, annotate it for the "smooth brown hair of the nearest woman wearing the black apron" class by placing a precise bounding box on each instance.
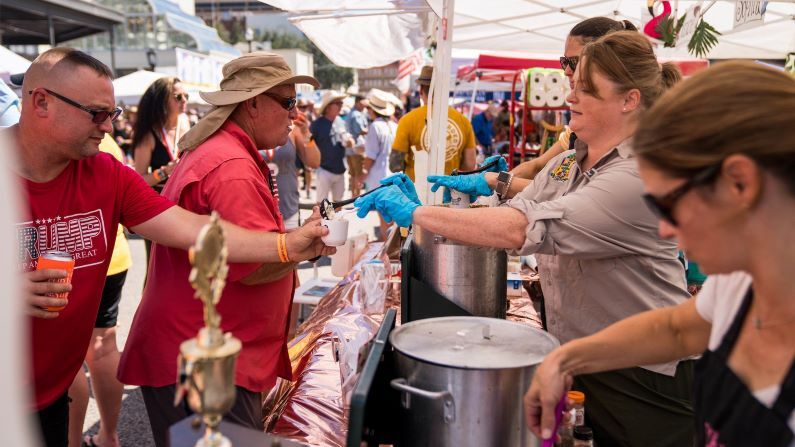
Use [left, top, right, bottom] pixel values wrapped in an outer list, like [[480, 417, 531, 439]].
[[634, 61, 795, 195]]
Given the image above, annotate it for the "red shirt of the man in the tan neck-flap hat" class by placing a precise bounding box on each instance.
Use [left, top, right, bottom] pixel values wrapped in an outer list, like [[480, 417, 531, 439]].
[[119, 122, 293, 392]]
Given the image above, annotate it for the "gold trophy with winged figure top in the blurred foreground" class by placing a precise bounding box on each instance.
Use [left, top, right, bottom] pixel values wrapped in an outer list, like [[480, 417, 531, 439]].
[[174, 213, 242, 447]]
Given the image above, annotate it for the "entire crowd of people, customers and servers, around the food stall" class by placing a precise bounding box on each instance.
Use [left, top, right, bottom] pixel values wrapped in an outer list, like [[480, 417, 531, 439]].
[[4, 12, 795, 446]]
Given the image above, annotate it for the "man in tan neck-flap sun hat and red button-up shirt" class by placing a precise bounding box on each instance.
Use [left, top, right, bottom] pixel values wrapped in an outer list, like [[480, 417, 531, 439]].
[[119, 52, 328, 446]]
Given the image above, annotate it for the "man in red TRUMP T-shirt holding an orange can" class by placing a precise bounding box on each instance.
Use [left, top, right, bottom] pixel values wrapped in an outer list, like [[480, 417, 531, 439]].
[[7, 48, 332, 446]]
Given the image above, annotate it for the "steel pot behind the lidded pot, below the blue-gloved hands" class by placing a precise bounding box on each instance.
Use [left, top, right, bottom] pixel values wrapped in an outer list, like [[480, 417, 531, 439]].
[[414, 225, 508, 318]]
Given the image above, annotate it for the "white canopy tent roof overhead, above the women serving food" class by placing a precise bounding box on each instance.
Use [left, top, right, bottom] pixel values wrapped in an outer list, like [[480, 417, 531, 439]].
[[261, 0, 795, 68]]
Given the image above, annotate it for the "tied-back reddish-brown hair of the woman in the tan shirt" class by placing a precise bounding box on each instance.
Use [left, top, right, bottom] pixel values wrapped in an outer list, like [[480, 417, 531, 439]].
[[577, 31, 682, 108]]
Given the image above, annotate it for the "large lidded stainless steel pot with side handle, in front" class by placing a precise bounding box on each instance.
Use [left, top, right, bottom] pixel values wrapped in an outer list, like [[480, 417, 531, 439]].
[[389, 317, 558, 447]]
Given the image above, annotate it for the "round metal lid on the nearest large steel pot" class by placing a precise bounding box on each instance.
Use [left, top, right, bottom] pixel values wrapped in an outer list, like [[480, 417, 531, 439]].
[[389, 317, 559, 369]]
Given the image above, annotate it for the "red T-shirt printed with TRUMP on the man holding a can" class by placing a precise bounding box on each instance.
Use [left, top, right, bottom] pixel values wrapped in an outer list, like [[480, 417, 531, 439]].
[[17, 153, 173, 410]]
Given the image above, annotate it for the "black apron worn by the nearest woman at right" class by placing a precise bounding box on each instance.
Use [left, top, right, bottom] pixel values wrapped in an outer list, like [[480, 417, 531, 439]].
[[693, 288, 795, 447]]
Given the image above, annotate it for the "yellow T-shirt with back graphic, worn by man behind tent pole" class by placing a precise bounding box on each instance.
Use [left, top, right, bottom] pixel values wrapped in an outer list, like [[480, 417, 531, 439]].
[[392, 106, 475, 181]]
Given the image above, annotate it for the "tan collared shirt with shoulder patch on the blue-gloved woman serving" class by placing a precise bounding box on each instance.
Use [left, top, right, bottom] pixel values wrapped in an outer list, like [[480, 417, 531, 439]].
[[506, 140, 690, 375]]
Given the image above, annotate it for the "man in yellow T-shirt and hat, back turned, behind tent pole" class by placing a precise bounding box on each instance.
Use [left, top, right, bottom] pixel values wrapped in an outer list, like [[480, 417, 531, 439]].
[[389, 65, 477, 181]]
